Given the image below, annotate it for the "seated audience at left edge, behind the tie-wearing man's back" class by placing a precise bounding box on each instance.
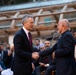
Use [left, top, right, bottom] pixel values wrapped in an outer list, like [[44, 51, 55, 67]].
[[0, 43, 14, 75]]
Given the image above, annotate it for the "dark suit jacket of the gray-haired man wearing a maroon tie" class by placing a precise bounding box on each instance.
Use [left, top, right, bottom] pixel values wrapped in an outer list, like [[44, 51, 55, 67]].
[[13, 28, 32, 75]]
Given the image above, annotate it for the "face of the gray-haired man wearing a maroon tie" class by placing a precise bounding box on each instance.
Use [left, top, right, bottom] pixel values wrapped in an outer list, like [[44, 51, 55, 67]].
[[24, 18, 34, 31]]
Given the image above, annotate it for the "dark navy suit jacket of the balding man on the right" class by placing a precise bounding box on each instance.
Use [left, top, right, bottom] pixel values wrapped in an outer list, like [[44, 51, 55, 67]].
[[40, 30, 75, 75]]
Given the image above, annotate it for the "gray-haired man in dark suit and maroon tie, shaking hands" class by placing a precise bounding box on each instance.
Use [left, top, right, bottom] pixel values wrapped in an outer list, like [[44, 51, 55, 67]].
[[12, 14, 37, 75]]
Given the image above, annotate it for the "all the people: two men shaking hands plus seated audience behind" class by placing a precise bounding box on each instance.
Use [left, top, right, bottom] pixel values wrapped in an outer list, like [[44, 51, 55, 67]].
[[0, 14, 76, 75]]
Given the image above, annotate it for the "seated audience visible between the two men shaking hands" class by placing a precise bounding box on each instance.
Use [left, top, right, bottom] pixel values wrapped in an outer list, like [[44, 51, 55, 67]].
[[33, 39, 55, 75]]
